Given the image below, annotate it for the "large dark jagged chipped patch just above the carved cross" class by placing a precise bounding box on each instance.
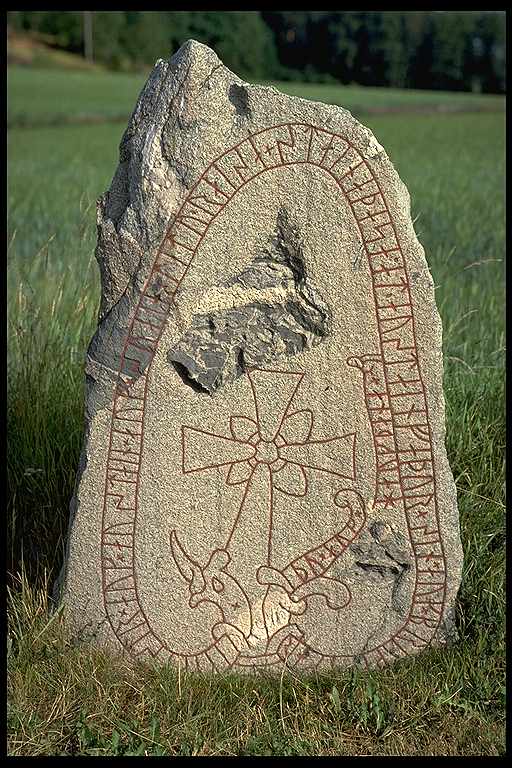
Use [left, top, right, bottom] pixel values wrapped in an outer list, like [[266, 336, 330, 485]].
[[168, 209, 331, 394]]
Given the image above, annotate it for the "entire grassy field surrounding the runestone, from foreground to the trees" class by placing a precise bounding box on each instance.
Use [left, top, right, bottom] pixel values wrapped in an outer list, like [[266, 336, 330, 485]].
[[7, 69, 505, 756]]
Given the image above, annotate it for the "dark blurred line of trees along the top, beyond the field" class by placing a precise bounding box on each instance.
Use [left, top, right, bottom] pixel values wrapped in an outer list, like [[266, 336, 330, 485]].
[[8, 11, 506, 93]]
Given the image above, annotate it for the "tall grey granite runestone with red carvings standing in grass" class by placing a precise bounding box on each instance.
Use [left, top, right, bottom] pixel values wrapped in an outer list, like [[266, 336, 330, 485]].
[[56, 41, 462, 671]]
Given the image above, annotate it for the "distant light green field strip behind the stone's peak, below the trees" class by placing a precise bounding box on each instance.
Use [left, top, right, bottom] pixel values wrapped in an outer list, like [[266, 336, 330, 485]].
[[8, 66, 505, 127]]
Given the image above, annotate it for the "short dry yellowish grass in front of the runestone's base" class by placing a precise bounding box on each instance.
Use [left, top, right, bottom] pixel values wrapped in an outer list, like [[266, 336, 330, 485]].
[[8, 568, 504, 756]]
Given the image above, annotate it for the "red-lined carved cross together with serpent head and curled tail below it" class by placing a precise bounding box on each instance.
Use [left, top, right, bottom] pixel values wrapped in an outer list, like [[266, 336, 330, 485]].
[[166, 369, 365, 664]]
